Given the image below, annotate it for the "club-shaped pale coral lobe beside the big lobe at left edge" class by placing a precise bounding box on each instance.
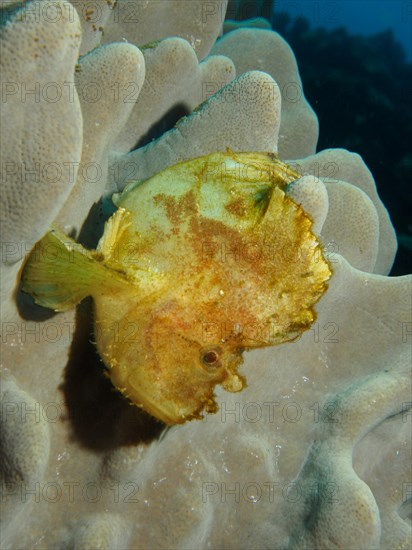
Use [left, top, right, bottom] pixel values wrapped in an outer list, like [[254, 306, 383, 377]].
[[57, 43, 145, 233]]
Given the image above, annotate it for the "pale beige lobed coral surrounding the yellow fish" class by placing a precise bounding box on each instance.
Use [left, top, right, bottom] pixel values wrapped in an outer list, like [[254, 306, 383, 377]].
[[0, 0, 412, 550]]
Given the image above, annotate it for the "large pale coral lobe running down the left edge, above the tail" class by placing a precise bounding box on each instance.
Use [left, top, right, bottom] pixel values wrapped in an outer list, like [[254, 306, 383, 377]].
[[0, 2, 83, 319]]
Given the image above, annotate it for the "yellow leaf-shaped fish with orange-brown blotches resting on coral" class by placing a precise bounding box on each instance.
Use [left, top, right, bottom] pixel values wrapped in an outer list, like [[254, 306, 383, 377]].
[[23, 150, 331, 424]]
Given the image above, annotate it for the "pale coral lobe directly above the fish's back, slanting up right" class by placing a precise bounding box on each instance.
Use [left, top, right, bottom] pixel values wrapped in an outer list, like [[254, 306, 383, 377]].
[[112, 71, 280, 189]]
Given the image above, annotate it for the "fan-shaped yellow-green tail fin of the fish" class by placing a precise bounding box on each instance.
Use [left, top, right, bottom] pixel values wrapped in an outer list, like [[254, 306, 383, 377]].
[[22, 228, 116, 311]]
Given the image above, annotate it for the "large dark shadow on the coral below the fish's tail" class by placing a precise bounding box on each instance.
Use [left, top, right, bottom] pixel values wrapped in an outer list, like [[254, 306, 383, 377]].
[[60, 300, 165, 451]]
